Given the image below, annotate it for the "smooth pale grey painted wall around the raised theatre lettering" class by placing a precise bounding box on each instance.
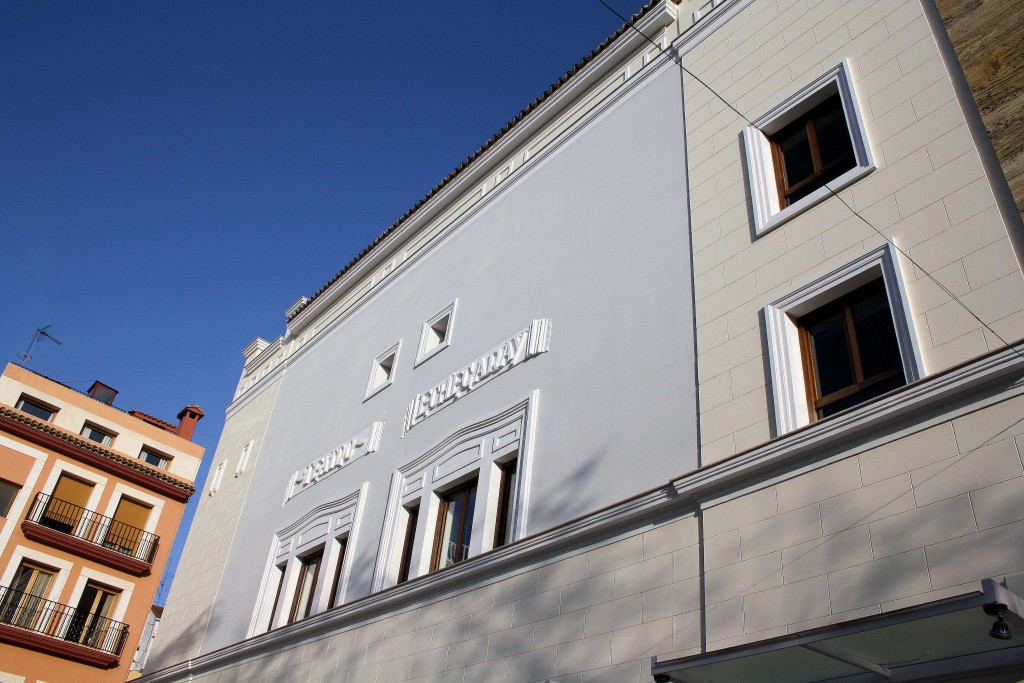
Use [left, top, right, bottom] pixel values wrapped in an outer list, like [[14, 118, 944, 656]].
[[202, 61, 696, 652]]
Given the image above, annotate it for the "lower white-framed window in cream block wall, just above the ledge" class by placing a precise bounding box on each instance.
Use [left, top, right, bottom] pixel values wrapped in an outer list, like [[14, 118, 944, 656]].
[[765, 243, 924, 434]]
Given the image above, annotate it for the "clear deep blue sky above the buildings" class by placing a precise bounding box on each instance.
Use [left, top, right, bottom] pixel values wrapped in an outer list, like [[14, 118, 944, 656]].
[[0, 0, 642, 598]]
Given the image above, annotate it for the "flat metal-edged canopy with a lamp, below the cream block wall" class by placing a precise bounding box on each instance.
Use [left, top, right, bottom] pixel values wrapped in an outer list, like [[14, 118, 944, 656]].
[[651, 579, 1024, 683]]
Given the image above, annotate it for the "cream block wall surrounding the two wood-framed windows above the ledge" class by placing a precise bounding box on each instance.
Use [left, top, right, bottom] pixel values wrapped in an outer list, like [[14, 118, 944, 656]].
[[683, 0, 1024, 464]]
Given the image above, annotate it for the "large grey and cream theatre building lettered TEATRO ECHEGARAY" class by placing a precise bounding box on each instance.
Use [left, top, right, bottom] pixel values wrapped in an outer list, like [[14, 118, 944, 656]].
[[144, 0, 1024, 683]]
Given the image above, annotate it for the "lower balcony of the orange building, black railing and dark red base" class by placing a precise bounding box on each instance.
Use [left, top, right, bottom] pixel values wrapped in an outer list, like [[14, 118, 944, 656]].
[[0, 586, 128, 669]]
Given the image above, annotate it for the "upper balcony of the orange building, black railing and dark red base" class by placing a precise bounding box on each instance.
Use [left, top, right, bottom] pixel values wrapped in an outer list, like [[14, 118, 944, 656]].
[[22, 494, 160, 577]]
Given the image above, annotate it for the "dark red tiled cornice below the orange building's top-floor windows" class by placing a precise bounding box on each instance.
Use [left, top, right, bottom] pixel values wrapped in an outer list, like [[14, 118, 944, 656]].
[[0, 405, 196, 503]]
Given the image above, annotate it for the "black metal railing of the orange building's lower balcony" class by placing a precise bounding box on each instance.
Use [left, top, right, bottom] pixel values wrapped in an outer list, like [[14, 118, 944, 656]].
[[0, 586, 128, 656]]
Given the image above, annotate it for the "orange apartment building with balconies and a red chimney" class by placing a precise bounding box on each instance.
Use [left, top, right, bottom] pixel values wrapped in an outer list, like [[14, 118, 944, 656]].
[[0, 365, 203, 683]]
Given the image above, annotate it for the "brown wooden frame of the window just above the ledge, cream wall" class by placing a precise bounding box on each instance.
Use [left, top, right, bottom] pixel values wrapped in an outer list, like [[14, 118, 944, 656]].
[[796, 280, 906, 422]]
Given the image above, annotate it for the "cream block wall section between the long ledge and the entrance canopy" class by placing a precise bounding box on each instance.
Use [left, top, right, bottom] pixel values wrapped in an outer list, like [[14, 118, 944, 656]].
[[705, 397, 1024, 648]]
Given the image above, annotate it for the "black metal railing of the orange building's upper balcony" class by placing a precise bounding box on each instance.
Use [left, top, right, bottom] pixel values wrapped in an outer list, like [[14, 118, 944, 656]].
[[26, 494, 160, 563]]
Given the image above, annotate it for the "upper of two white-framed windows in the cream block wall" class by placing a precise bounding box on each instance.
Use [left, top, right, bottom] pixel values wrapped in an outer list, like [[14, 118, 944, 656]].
[[743, 61, 874, 234]]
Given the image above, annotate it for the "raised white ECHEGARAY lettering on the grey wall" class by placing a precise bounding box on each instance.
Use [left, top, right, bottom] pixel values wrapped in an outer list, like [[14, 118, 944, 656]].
[[401, 318, 551, 436]]
